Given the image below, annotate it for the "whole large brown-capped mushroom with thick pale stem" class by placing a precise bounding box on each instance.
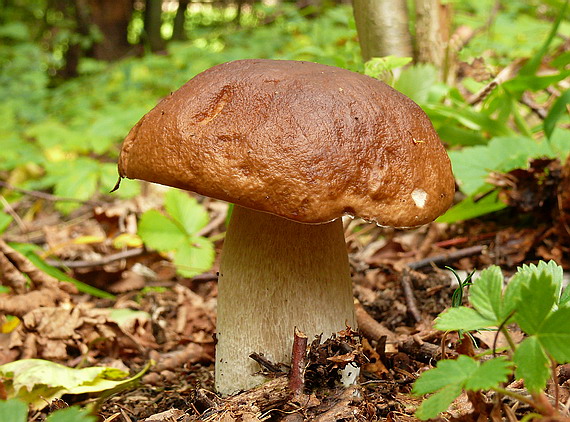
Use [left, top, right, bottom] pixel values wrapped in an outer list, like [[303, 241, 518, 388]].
[[115, 59, 454, 395]]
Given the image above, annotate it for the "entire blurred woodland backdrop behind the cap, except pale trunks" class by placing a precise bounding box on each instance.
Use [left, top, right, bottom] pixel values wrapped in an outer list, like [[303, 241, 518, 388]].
[[0, 0, 570, 223]]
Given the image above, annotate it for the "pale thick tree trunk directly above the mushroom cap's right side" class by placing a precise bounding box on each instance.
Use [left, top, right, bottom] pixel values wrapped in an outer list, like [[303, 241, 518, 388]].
[[352, 0, 413, 61]]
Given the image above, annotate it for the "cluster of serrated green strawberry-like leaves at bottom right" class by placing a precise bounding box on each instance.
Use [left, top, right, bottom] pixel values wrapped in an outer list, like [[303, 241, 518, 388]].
[[413, 261, 570, 419]]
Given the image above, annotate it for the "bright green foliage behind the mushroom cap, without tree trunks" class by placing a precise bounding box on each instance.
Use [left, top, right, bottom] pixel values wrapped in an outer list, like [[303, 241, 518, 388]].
[[0, 0, 569, 221]]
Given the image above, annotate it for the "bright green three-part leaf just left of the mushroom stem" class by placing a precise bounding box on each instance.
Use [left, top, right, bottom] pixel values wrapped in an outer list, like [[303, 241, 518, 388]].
[[138, 189, 215, 277]]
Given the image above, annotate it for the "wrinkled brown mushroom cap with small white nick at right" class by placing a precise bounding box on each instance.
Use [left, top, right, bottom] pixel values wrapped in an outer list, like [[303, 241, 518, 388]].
[[119, 60, 454, 227]]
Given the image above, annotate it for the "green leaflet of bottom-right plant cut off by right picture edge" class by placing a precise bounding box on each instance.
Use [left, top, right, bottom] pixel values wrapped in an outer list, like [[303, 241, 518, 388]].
[[537, 306, 570, 363]]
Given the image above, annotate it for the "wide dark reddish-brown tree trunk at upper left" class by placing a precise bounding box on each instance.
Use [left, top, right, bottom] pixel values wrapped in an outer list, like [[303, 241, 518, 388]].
[[86, 0, 133, 60]]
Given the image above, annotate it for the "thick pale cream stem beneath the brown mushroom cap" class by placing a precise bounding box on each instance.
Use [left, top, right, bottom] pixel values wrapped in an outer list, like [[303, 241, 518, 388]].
[[216, 206, 356, 395]]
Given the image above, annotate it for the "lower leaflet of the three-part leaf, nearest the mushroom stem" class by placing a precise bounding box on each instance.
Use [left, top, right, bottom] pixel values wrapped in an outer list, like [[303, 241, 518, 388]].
[[174, 237, 216, 278]]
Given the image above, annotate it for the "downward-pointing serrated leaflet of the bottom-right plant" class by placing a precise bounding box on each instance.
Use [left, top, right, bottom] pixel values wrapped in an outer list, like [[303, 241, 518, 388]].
[[513, 336, 550, 392]]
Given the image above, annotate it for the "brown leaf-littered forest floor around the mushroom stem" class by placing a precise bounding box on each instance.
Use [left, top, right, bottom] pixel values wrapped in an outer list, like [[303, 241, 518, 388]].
[[0, 156, 570, 422]]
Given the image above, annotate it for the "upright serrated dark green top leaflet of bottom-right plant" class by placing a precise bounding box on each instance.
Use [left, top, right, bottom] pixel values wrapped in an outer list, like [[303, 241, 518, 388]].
[[515, 271, 557, 335]]
